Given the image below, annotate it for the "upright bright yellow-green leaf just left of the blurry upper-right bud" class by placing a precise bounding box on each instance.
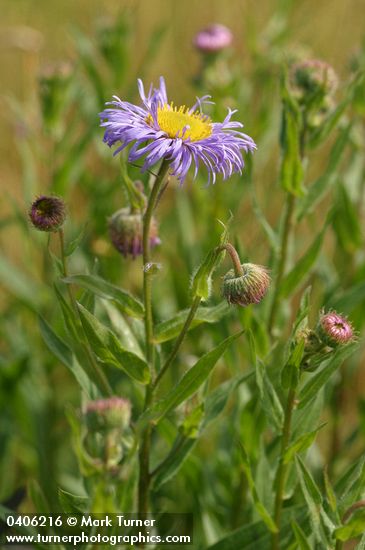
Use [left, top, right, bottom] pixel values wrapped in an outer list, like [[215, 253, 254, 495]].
[[280, 70, 304, 196]]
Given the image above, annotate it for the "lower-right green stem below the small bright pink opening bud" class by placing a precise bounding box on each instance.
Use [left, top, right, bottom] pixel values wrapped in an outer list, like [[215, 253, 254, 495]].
[[271, 388, 295, 550]]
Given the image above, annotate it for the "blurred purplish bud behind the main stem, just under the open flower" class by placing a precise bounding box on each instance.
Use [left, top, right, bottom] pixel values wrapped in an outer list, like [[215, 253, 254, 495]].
[[108, 208, 161, 258]]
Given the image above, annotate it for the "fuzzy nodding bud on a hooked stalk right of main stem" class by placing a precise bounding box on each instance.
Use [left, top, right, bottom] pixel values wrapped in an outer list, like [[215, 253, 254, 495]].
[[222, 264, 270, 307]]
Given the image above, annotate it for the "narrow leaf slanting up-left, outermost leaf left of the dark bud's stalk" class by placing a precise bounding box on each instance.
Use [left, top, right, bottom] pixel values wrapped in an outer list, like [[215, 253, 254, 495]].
[[39, 317, 96, 398]]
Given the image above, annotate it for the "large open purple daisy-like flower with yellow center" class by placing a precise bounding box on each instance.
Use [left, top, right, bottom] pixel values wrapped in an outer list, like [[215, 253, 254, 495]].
[[100, 77, 256, 183]]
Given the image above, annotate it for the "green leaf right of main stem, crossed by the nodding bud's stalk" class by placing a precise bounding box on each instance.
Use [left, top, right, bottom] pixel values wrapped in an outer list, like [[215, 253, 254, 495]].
[[154, 302, 230, 344]]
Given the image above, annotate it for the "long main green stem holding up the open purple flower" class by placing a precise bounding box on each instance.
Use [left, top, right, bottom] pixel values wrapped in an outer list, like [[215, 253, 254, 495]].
[[138, 160, 169, 514]]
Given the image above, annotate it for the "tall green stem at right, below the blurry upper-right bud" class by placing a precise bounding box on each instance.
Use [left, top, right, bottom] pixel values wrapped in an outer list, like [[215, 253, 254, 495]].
[[268, 193, 296, 334]]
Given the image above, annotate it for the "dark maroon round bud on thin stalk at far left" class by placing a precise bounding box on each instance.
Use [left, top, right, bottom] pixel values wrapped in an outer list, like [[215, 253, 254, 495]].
[[29, 195, 66, 232]]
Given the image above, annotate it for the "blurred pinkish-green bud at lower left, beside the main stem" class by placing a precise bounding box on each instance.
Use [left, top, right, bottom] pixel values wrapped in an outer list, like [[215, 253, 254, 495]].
[[84, 397, 131, 433]]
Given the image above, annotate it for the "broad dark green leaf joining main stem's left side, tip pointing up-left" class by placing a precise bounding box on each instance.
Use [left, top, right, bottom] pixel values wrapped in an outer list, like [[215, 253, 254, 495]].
[[78, 304, 150, 384]]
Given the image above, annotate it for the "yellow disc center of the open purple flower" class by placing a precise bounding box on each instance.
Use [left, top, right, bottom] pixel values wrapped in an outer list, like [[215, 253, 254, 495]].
[[149, 103, 213, 141]]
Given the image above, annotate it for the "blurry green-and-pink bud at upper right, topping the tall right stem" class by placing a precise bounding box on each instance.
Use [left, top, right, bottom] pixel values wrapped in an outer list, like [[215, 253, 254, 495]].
[[290, 59, 338, 103]]
